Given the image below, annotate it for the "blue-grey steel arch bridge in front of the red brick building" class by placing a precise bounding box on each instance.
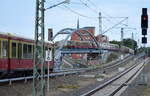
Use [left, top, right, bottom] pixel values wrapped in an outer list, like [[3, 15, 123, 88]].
[[52, 28, 132, 71]]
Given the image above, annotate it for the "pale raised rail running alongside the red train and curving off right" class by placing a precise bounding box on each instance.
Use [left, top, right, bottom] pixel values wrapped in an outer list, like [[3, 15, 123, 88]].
[[0, 56, 133, 85]]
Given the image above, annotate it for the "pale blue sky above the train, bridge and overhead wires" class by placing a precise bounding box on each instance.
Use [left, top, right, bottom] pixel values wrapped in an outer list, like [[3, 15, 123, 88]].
[[0, 0, 150, 45]]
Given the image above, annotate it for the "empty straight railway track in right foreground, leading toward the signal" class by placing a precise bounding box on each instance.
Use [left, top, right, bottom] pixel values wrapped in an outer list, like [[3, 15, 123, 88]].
[[81, 59, 150, 96]]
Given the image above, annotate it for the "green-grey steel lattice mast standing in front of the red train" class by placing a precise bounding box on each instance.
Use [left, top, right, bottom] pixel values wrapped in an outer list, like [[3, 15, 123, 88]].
[[33, 0, 45, 96]]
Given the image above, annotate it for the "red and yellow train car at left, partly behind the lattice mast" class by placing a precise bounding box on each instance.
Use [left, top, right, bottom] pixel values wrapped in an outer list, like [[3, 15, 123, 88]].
[[0, 33, 53, 74]]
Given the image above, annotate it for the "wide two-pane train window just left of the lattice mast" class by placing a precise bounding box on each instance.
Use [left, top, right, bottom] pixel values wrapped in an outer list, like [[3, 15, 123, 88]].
[[23, 44, 33, 59]]
